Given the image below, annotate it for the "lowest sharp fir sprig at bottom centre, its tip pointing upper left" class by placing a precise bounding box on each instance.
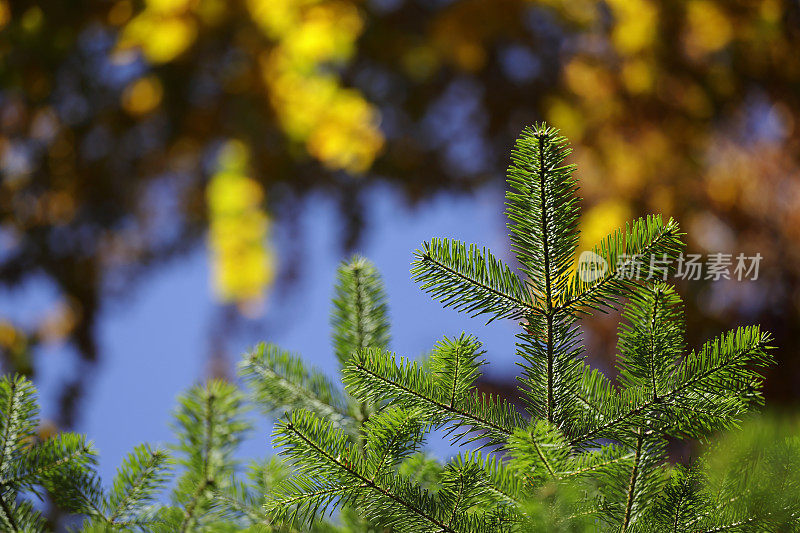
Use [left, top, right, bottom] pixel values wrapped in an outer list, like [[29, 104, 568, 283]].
[[267, 411, 506, 533]]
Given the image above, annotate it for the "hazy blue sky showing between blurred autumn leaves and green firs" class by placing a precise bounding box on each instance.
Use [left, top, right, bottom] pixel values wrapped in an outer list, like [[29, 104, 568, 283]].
[[20, 182, 516, 483]]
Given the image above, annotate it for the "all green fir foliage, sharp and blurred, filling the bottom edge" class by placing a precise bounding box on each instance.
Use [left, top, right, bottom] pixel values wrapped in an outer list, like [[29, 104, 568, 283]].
[[0, 125, 800, 533]]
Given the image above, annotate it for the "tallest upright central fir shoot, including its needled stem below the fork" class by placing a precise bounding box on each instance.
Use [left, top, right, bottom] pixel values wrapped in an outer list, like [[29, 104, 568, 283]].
[[506, 124, 580, 432]]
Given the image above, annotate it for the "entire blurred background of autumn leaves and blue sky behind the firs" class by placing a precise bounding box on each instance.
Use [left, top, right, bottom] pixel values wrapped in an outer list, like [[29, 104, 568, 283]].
[[0, 0, 800, 482]]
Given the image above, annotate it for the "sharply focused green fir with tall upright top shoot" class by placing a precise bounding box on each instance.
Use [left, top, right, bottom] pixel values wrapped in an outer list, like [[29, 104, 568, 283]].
[[262, 125, 797, 532]]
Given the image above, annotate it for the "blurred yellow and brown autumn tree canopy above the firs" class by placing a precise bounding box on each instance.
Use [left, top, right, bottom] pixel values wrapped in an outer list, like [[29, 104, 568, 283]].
[[0, 0, 800, 425]]
